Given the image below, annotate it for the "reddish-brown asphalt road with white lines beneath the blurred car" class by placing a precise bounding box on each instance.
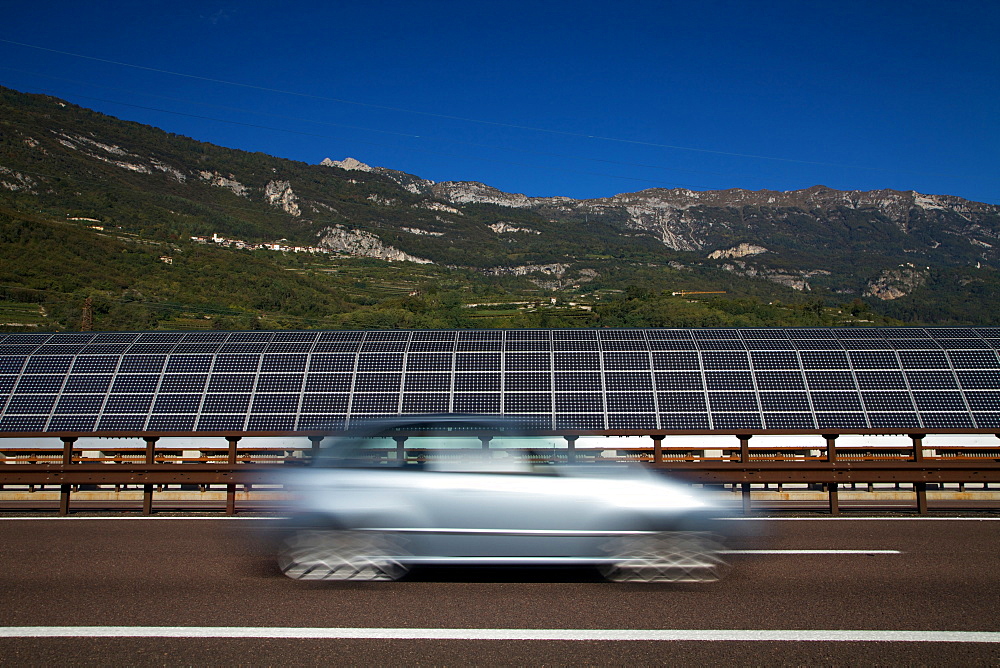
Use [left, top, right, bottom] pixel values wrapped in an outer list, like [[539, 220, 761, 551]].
[[0, 514, 1000, 666]]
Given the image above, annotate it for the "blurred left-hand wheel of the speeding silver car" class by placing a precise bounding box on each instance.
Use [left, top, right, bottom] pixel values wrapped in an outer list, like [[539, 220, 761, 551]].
[[278, 529, 409, 581]]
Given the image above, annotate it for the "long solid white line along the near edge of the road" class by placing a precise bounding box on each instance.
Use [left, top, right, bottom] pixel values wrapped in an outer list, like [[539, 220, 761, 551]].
[[0, 626, 1000, 643]]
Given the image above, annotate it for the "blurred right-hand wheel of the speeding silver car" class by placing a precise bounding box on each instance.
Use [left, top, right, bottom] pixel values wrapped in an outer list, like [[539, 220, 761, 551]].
[[601, 531, 729, 582]]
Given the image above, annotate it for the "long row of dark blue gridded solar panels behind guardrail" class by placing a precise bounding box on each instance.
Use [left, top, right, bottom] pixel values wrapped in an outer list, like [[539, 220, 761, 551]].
[[0, 328, 1000, 433]]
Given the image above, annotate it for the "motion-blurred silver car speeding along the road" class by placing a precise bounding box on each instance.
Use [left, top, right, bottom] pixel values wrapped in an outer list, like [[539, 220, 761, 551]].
[[270, 415, 726, 582]]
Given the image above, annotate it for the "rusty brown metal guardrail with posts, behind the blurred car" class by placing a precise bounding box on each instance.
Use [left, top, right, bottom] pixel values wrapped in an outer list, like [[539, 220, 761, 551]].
[[0, 435, 1000, 514]]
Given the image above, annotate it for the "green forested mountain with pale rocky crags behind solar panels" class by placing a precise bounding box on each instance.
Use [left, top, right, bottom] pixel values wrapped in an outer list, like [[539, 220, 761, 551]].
[[0, 88, 1000, 327]]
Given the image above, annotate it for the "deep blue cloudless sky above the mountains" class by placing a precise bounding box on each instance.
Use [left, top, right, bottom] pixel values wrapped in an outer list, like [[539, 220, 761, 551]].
[[0, 0, 1000, 203]]
